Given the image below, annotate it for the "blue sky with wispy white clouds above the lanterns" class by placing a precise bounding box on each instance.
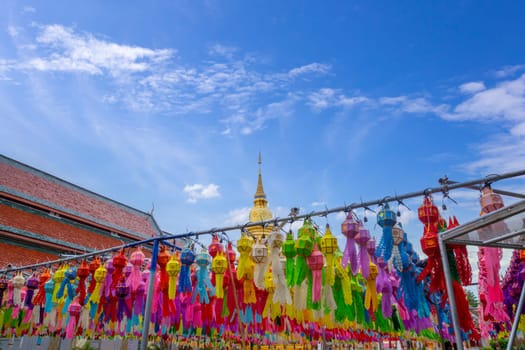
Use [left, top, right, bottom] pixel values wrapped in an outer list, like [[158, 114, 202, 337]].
[[0, 1, 525, 274]]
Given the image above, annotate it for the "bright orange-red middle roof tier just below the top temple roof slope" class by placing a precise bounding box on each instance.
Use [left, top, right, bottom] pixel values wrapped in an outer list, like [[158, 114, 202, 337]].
[[0, 205, 123, 250]]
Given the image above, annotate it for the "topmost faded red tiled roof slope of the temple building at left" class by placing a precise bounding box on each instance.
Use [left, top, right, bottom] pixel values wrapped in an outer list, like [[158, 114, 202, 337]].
[[0, 155, 158, 236]]
